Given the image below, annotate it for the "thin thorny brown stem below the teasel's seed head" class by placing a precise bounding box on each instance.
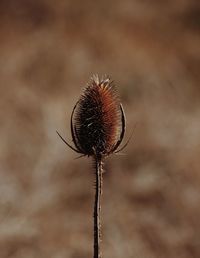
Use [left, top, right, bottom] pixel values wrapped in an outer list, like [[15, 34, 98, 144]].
[[93, 157, 103, 258]]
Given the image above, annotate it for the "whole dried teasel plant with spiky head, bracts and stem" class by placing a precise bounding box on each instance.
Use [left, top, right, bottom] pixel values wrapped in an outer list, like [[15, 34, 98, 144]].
[[57, 75, 128, 258]]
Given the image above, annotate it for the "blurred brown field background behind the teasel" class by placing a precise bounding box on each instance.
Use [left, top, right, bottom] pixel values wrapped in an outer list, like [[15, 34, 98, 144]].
[[0, 0, 200, 258]]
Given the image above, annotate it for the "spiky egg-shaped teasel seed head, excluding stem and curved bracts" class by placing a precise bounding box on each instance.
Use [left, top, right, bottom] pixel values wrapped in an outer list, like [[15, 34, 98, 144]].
[[73, 76, 121, 157]]
